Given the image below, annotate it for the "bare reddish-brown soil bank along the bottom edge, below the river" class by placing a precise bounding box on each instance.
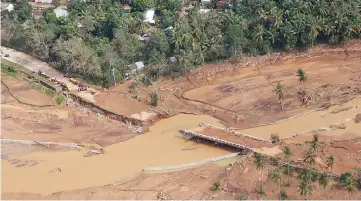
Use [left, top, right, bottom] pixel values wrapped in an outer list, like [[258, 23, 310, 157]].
[[3, 152, 360, 200]]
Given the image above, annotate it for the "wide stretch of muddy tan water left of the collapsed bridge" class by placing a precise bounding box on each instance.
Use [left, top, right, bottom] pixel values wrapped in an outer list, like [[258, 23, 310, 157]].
[[2, 114, 230, 195]]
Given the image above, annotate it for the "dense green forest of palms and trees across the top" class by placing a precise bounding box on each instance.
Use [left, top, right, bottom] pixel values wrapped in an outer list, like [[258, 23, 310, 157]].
[[1, 0, 361, 87]]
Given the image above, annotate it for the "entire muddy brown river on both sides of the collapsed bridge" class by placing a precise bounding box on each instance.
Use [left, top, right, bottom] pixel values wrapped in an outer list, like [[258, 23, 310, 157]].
[[2, 98, 361, 195]]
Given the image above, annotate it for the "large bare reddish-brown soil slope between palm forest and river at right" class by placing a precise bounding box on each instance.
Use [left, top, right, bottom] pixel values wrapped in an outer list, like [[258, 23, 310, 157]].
[[127, 41, 361, 129]]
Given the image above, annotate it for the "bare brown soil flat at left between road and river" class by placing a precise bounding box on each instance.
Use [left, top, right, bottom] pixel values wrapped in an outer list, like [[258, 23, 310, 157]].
[[1, 72, 135, 146]]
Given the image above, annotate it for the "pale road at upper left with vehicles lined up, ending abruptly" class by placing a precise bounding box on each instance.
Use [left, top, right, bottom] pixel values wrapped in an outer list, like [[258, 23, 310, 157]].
[[1, 46, 95, 103]]
